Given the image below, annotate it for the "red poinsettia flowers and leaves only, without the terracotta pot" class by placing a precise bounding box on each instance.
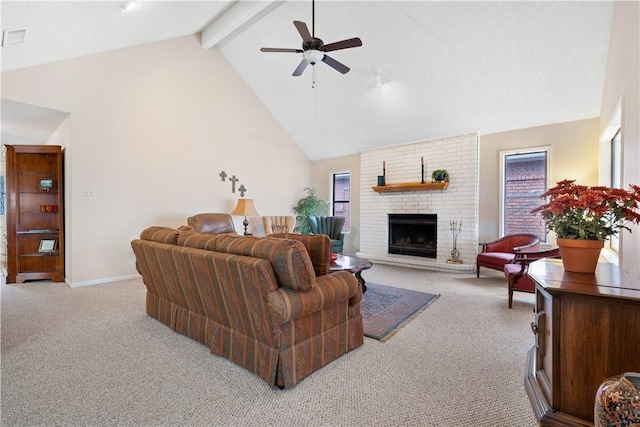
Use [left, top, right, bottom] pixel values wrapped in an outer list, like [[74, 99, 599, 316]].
[[532, 179, 640, 240]]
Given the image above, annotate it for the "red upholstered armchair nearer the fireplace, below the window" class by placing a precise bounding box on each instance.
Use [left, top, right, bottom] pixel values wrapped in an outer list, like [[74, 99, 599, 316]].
[[476, 233, 540, 277]]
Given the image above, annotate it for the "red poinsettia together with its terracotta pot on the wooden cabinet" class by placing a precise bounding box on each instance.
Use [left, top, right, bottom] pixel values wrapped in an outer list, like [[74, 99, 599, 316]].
[[532, 179, 640, 273]]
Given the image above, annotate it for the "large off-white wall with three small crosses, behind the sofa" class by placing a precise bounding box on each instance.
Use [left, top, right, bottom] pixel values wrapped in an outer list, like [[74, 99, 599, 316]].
[[1, 36, 310, 286]]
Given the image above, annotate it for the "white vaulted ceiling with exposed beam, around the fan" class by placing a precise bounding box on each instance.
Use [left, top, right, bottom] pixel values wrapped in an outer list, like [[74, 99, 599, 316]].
[[1, 0, 613, 160]]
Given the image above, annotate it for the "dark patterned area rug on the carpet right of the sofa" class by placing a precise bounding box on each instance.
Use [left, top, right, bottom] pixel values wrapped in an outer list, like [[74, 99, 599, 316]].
[[360, 283, 440, 342]]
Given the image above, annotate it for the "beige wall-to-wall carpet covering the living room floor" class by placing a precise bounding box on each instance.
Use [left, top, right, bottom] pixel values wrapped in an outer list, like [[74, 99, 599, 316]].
[[0, 265, 537, 427]]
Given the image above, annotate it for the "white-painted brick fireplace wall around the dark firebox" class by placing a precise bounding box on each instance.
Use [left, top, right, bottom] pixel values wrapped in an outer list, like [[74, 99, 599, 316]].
[[357, 134, 478, 271]]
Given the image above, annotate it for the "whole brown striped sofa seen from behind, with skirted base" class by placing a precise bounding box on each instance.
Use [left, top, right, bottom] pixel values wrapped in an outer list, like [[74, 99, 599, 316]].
[[131, 227, 364, 388]]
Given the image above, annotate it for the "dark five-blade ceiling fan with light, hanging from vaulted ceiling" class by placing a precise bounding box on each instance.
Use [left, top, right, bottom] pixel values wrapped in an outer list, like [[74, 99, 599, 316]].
[[260, 0, 362, 76]]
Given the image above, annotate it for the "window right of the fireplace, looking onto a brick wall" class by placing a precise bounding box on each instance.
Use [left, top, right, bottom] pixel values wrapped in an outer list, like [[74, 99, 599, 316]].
[[501, 148, 548, 241]]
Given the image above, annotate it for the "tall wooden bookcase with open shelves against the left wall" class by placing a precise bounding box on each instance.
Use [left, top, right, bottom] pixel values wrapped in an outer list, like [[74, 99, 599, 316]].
[[6, 145, 64, 283]]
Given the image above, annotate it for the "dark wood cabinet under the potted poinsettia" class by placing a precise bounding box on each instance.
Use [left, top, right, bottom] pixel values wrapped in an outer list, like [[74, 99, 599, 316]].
[[525, 259, 640, 426]]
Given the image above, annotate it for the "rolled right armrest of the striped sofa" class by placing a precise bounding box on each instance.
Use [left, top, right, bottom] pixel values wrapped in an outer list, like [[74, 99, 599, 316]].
[[267, 271, 362, 325]]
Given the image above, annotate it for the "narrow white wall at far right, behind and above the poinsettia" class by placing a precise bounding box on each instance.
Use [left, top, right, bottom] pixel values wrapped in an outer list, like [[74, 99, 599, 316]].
[[600, 1, 640, 278]]
